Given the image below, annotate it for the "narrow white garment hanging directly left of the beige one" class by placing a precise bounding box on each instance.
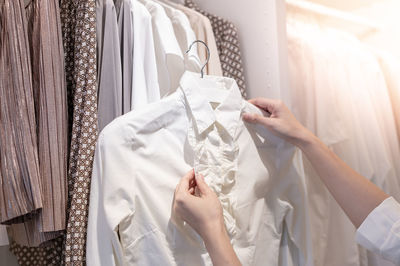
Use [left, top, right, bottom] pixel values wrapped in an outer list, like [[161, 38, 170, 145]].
[[157, 1, 201, 72]]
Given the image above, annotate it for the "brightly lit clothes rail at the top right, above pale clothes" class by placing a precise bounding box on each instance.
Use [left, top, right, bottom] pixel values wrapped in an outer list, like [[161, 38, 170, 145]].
[[286, 0, 382, 33]]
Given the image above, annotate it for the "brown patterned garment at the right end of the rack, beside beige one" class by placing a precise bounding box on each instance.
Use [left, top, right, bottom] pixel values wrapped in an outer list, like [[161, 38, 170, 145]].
[[185, 0, 247, 98]]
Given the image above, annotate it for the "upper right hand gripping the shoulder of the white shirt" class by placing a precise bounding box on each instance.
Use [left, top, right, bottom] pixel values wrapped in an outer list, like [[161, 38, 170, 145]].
[[243, 98, 312, 145]]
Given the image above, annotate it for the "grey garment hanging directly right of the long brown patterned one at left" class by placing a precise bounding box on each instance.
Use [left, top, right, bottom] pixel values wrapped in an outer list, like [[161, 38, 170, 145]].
[[96, 0, 123, 131]]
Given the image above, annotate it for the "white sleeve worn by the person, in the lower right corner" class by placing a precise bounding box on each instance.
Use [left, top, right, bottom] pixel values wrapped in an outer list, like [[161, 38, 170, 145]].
[[356, 197, 400, 265]]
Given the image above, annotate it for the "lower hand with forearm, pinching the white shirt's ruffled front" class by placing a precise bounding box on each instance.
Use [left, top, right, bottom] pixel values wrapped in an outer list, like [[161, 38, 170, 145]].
[[172, 170, 241, 266]]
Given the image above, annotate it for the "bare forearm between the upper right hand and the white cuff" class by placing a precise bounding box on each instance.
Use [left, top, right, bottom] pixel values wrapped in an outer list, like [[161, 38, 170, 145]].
[[298, 130, 389, 228]]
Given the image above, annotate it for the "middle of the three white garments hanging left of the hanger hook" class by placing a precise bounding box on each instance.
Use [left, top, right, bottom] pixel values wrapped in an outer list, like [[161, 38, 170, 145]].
[[139, 0, 185, 97]]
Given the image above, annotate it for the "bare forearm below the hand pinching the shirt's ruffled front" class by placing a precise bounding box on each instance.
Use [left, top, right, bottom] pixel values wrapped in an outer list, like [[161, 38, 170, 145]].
[[204, 228, 241, 266]]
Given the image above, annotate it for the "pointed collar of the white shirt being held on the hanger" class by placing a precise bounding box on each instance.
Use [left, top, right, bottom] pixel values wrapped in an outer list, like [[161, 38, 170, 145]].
[[180, 71, 243, 138]]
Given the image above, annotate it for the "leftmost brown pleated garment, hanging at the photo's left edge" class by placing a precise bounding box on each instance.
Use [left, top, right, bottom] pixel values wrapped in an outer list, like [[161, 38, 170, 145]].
[[0, 0, 43, 227]]
